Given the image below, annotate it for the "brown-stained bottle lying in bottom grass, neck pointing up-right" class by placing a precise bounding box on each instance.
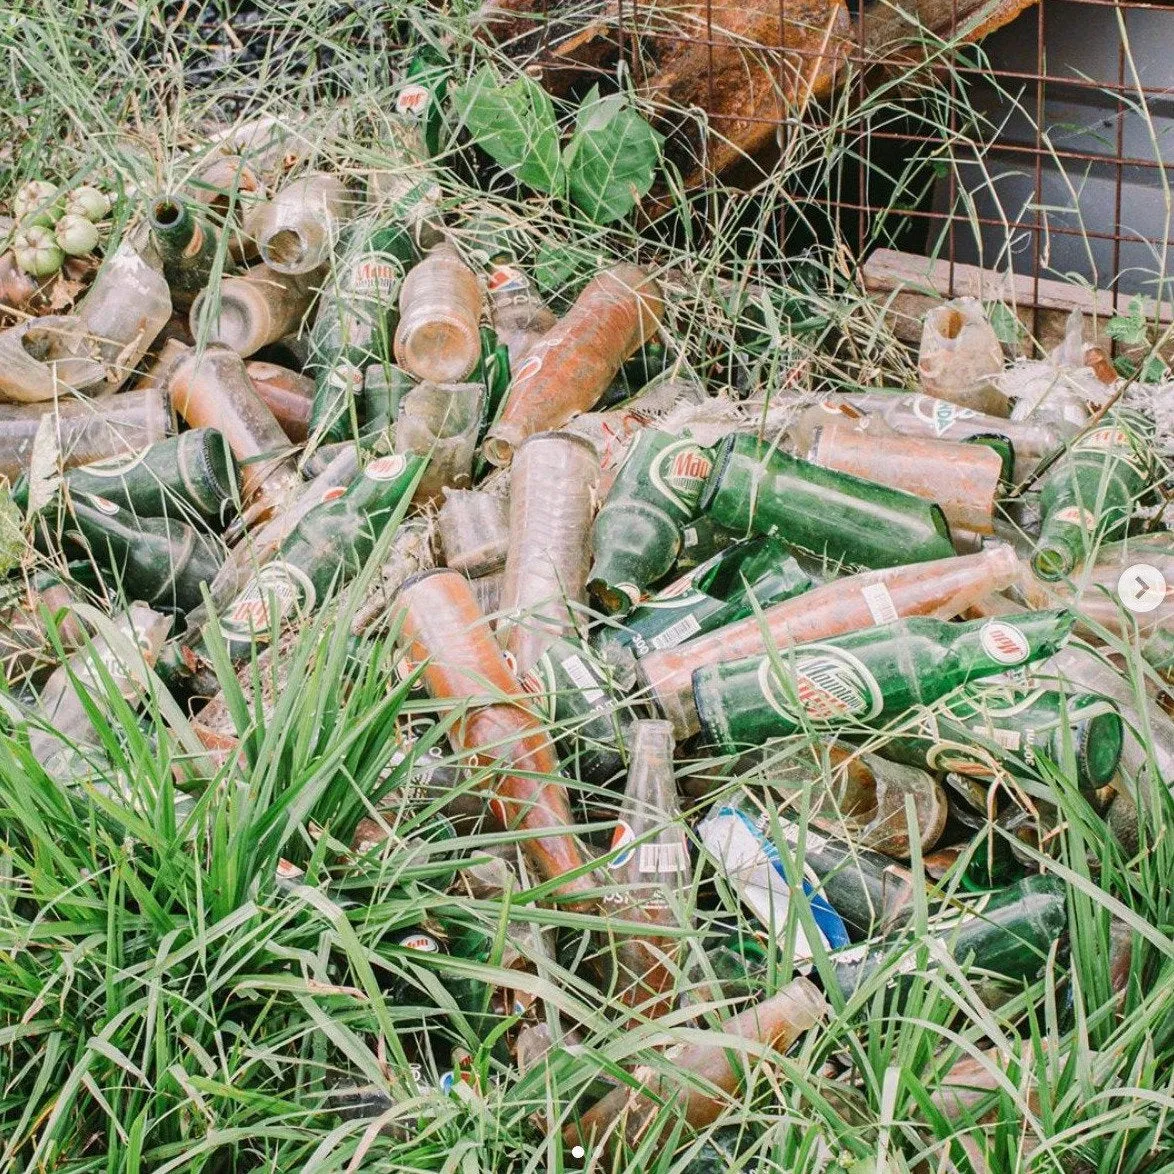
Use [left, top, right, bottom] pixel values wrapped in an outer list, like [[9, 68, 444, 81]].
[[562, 978, 828, 1156]]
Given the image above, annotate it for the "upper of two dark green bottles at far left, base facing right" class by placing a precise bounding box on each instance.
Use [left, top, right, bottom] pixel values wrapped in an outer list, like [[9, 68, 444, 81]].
[[13, 429, 237, 528]]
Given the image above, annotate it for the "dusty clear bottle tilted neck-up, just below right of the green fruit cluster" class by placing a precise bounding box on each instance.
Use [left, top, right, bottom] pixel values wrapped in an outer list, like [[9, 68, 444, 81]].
[[73, 241, 171, 391]]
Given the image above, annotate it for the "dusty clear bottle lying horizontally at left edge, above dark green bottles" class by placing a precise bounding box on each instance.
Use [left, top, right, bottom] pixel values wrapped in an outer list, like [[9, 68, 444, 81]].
[[0, 389, 173, 484]]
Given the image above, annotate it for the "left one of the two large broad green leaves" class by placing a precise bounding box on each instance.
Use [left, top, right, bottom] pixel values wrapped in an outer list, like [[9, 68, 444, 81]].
[[452, 66, 564, 193]]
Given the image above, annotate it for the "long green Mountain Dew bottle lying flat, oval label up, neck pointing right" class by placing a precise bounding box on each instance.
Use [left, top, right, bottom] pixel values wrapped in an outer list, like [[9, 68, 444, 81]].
[[693, 610, 1075, 753]]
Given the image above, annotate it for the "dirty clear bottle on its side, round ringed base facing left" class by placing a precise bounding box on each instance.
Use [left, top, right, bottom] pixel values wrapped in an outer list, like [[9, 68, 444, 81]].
[[188, 265, 315, 357]]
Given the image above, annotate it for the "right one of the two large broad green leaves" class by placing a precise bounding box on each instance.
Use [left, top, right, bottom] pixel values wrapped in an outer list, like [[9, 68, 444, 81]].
[[564, 86, 664, 224]]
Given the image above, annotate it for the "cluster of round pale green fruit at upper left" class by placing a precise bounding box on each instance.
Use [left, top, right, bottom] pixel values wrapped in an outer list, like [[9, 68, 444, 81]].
[[9, 180, 110, 277]]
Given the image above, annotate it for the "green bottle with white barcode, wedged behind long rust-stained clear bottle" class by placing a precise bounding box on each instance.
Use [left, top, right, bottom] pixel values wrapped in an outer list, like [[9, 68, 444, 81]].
[[593, 538, 814, 666]]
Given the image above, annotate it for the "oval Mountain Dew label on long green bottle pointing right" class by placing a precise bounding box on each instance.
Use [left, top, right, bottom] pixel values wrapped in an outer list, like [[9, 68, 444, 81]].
[[758, 645, 884, 726]]
